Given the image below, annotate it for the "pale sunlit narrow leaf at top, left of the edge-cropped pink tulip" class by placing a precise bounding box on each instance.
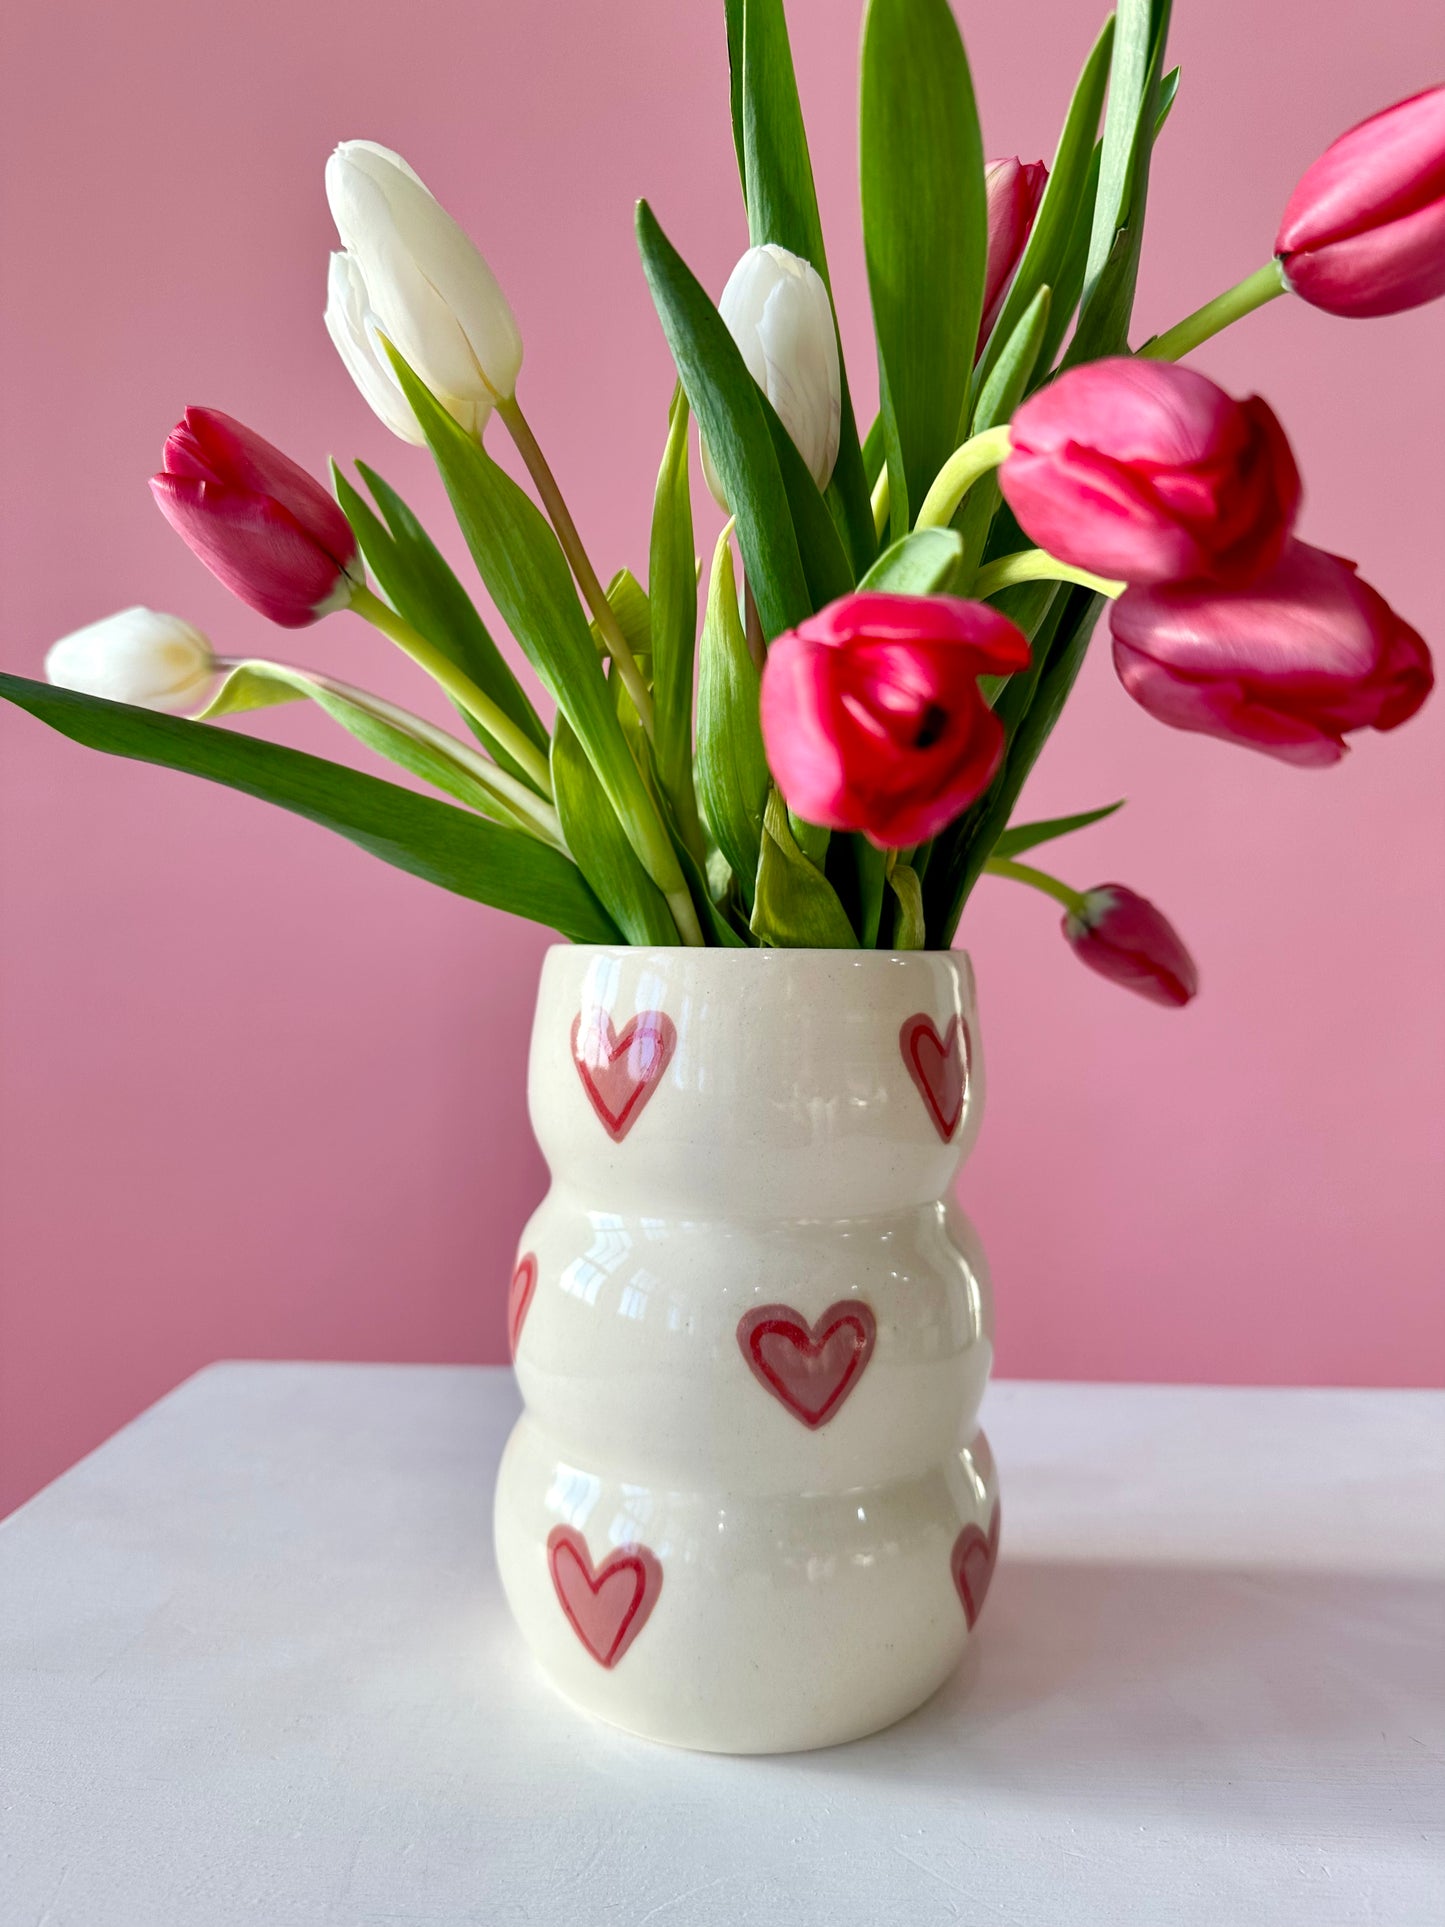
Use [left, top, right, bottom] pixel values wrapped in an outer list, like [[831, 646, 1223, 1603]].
[[1064, 0, 1169, 368]]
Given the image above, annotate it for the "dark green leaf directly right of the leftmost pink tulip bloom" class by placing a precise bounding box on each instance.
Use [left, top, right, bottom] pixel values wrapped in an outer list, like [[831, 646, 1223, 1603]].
[[331, 462, 547, 786]]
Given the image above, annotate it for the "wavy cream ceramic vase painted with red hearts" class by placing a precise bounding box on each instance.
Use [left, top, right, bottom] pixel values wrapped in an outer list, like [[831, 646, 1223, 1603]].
[[495, 946, 998, 1754]]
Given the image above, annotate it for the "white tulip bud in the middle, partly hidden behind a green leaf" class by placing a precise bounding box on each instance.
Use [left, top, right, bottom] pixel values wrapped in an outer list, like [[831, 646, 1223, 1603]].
[[703, 245, 842, 511]]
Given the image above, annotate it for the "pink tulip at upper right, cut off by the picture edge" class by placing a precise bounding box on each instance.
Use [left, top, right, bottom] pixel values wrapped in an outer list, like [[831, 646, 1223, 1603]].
[[1274, 87, 1445, 316]]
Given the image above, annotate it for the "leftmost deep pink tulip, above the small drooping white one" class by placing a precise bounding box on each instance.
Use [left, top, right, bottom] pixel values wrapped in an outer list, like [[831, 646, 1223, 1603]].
[[150, 409, 364, 628]]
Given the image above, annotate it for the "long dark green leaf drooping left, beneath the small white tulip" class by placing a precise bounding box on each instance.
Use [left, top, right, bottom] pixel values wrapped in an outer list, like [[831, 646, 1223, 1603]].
[[0, 674, 618, 944]]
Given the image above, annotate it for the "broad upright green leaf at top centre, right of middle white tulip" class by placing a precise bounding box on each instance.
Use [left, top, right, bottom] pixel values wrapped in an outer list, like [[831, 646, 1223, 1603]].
[[859, 0, 988, 536]]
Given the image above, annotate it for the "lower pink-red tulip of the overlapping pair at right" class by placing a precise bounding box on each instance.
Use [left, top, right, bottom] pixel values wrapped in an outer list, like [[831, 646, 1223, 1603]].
[[1112, 541, 1435, 765]]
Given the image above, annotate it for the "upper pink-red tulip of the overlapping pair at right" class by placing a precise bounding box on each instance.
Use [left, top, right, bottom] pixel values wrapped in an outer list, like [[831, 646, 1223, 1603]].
[[1000, 356, 1301, 582]]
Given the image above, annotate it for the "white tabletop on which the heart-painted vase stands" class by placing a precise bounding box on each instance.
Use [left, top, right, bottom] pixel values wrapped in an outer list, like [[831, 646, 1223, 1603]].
[[0, 1364, 1445, 1927]]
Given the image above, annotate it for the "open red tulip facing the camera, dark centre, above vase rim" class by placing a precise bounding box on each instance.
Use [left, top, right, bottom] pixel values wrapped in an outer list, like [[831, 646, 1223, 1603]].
[[763, 590, 1029, 850]]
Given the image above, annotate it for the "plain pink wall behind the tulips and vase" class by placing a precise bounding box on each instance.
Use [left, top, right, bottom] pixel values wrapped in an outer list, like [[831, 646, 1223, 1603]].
[[0, 0, 1445, 1501]]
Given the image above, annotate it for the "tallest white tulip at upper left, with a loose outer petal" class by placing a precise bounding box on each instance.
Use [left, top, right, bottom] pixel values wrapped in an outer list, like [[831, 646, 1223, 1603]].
[[326, 141, 522, 441]]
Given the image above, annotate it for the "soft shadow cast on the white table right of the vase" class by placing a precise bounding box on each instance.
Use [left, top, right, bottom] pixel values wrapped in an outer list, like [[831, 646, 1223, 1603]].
[[813, 1559, 1445, 1833]]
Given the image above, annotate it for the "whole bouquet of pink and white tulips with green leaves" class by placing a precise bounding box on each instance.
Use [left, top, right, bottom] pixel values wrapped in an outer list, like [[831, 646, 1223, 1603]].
[[0, 0, 1445, 1004]]
